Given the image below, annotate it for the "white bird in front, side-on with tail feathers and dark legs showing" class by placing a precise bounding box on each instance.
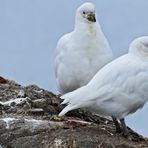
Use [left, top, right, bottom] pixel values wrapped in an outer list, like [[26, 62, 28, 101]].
[[59, 36, 148, 135]]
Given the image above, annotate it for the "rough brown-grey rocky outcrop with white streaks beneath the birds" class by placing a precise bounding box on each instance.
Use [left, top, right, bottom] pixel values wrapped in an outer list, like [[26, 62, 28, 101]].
[[0, 77, 148, 148]]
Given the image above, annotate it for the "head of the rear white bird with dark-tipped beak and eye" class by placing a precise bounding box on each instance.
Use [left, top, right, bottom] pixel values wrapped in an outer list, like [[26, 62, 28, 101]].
[[76, 2, 96, 23]]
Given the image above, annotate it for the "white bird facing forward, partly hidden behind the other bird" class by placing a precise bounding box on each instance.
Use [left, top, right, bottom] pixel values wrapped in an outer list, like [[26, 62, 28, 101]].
[[54, 3, 113, 94]]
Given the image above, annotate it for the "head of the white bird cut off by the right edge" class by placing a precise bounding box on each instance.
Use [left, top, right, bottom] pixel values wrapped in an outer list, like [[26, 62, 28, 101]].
[[129, 36, 148, 57]]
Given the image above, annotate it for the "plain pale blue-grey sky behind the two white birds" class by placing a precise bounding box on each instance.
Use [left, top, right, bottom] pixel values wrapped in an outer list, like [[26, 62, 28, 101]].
[[0, 0, 148, 136]]
